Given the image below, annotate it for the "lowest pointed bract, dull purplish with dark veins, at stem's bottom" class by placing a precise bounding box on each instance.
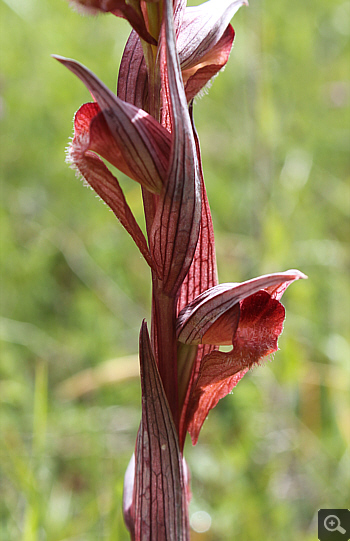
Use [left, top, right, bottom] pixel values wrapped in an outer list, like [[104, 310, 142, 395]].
[[130, 322, 189, 541]]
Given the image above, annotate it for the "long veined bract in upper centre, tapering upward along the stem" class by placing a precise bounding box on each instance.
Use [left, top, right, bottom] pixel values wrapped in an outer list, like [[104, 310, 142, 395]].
[[150, 0, 201, 295]]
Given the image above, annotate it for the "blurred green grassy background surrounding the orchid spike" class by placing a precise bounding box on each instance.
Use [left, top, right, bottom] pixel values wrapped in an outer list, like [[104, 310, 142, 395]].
[[0, 0, 350, 541]]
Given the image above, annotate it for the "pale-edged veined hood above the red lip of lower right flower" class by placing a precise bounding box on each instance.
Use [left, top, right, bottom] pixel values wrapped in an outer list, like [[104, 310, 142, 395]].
[[177, 270, 306, 344]]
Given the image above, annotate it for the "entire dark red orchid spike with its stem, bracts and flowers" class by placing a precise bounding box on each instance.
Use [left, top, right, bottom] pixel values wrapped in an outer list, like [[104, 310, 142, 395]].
[[55, 0, 305, 541]]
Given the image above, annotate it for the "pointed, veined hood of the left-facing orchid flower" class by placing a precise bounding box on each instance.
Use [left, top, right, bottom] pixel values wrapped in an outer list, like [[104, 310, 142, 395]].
[[54, 56, 170, 193]]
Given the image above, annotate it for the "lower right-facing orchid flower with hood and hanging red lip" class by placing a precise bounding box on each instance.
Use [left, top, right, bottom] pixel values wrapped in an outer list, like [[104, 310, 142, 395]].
[[177, 270, 306, 444]]
